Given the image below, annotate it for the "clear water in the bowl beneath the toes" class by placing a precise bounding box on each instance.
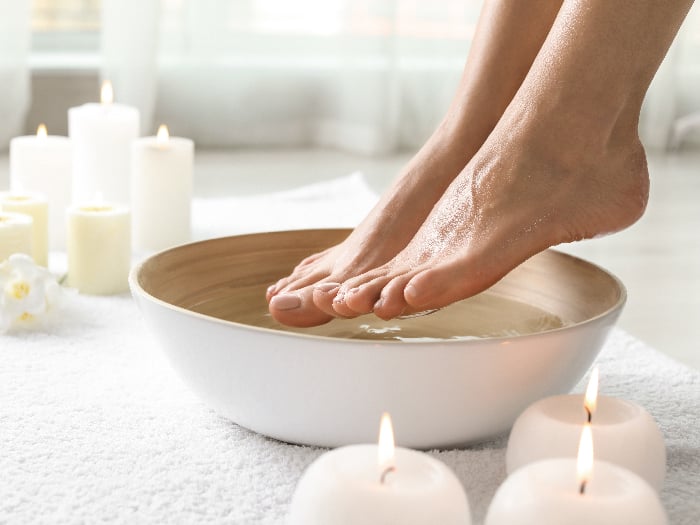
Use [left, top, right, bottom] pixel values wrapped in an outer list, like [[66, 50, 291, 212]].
[[191, 287, 571, 342]]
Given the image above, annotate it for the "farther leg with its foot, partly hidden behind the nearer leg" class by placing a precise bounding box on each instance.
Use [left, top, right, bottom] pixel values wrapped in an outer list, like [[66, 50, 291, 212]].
[[267, 0, 561, 326]]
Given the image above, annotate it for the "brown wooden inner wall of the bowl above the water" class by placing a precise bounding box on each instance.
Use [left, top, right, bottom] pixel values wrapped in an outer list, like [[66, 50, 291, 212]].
[[137, 229, 625, 330]]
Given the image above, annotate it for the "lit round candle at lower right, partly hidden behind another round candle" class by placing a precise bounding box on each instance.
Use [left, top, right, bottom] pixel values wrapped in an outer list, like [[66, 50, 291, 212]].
[[506, 369, 666, 490]]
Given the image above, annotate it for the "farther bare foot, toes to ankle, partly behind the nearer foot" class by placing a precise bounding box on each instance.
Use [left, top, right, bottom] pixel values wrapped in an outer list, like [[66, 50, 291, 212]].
[[267, 130, 478, 326]]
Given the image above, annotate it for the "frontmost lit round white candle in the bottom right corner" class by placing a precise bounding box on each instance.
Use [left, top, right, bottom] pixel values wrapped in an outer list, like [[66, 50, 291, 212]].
[[484, 424, 667, 525]]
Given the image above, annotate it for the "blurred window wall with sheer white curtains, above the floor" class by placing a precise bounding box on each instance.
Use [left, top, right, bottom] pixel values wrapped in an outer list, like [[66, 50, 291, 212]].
[[0, 0, 700, 148]]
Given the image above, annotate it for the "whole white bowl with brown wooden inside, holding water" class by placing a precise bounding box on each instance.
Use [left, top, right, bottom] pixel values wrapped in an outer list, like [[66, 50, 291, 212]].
[[130, 230, 626, 448]]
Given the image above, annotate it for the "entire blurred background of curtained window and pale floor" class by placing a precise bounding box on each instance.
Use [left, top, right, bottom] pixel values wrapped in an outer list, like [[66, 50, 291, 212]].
[[0, 0, 700, 368]]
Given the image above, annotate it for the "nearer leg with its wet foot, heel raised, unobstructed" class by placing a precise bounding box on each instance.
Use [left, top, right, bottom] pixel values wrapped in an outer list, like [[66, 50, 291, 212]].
[[336, 0, 692, 318]]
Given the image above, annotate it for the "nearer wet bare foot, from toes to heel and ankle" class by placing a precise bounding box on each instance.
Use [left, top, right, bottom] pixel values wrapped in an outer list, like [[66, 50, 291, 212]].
[[333, 107, 649, 319]]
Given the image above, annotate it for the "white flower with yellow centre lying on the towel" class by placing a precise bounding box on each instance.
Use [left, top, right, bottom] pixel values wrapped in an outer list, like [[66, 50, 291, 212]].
[[0, 253, 63, 334]]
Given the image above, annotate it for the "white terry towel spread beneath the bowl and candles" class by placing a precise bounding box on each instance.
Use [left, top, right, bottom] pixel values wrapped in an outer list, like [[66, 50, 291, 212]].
[[0, 177, 700, 525]]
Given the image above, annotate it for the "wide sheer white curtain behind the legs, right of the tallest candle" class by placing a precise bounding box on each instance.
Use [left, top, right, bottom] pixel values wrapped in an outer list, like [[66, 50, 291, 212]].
[[102, 0, 700, 153]]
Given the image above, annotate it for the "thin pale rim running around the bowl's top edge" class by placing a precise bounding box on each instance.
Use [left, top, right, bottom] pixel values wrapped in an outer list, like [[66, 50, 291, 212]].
[[129, 228, 627, 346]]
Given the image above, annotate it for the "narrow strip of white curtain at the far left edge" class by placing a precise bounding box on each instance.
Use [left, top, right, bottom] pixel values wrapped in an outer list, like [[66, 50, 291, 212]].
[[0, 0, 31, 149]]
